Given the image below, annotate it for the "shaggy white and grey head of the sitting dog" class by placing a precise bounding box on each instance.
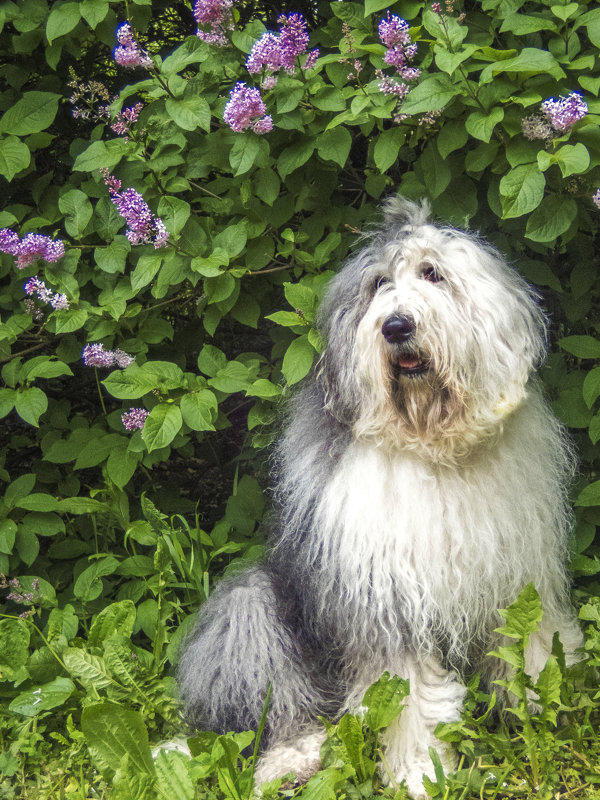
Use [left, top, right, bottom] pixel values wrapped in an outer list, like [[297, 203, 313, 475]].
[[319, 199, 545, 454]]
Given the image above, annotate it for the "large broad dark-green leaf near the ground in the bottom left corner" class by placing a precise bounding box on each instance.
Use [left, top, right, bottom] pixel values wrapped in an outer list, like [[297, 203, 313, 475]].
[[81, 703, 154, 781]]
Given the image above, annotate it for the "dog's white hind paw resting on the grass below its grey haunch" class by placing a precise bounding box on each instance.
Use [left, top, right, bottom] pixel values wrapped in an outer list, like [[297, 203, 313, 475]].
[[254, 733, 325, 786]]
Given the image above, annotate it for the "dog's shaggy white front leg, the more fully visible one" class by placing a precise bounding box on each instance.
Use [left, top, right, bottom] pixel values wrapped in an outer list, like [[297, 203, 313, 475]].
[[382, 656, 466, 798]]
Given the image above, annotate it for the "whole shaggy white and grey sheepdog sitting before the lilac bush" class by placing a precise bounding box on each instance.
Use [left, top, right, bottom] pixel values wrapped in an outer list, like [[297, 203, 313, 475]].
[[180, 199, 580, 796]]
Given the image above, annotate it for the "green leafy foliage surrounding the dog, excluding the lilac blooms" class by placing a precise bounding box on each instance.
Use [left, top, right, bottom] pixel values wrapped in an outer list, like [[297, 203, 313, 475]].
[[0, 0, 600, 797]]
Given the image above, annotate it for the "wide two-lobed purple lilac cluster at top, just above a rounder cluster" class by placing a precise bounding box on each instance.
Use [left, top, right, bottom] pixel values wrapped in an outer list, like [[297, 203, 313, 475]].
[[246, 14, 319, 89]]
